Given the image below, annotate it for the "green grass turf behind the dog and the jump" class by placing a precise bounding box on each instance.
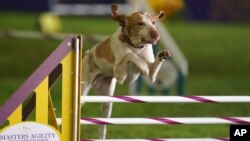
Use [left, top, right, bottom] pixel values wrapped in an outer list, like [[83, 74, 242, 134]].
[[0, 12, 250, 138]]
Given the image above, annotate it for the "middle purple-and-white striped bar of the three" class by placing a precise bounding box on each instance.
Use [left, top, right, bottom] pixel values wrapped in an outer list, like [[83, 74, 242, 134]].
[[80, 117, 250, 125]]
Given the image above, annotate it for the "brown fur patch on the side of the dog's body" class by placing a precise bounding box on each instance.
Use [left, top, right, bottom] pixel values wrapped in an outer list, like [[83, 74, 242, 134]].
[[96, 38, 115, 64]]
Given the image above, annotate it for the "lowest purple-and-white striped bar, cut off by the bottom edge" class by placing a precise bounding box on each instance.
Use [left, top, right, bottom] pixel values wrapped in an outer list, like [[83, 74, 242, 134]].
[[81, 138, 229, 141]]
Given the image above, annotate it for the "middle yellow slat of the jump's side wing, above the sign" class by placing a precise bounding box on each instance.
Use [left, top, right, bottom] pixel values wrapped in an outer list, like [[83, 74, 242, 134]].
[[35, 76, 49, 124]]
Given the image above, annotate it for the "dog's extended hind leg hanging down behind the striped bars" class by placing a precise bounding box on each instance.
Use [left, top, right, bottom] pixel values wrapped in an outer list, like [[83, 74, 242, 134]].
[[94, 76, 116, 139]]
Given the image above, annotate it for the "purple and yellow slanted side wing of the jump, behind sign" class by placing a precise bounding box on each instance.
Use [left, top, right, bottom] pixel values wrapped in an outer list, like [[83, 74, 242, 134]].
[[0, 35, 82, 141]]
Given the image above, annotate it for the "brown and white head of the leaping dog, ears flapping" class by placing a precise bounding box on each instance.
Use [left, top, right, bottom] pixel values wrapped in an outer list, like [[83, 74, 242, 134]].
[[111, 4, 166, 46]]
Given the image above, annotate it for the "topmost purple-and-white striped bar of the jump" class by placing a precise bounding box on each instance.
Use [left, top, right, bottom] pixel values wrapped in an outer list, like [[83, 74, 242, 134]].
[[81, 96, 250, 103]]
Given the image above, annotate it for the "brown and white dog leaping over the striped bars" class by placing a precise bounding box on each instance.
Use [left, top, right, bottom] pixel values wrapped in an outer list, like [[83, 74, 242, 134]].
[[82, 4, 170, 139]]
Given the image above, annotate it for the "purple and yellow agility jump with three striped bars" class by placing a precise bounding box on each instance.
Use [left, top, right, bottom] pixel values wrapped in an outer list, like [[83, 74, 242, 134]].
[[0, 35, 250, 141]]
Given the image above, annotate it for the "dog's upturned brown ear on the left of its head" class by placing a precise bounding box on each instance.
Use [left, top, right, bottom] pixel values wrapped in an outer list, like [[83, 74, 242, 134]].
[[111, 4, 127, 27]]
